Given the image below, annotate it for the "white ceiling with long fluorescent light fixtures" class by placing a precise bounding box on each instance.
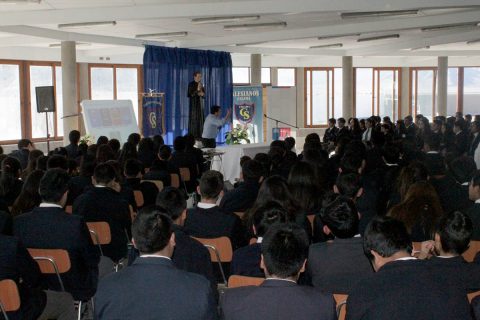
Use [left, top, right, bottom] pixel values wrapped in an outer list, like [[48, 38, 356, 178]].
[[0, 0, 480, 65]]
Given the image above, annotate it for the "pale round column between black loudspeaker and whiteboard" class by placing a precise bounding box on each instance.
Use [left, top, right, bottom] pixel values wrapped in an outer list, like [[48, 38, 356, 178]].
[[61, 41, 78, 145]]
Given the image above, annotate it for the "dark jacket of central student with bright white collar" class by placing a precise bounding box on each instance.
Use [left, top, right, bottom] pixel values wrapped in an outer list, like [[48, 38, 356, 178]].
[[185, 206, 247, 249]]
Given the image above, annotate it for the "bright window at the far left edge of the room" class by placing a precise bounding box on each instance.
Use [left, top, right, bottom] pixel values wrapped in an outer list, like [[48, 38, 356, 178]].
[[0, 64, 22, 140]]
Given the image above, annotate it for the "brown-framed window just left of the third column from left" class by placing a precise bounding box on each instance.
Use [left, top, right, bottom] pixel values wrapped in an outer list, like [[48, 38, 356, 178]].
[[305, 68, 342, 127]]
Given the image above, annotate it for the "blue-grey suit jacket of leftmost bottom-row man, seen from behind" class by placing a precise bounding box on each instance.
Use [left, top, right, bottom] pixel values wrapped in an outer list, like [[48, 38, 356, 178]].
[[95, 257, 217, 320]]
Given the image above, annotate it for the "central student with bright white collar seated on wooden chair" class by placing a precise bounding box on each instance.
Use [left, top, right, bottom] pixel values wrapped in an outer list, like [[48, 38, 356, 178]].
[[185, 170, 246, 249]]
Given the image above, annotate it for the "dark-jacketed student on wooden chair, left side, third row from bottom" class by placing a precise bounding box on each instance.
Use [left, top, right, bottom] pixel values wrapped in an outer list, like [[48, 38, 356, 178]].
[[73, 163, 131, 262]]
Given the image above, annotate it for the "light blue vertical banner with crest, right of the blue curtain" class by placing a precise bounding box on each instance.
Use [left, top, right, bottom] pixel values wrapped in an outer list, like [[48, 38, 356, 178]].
[[232, 86, 263, 143]]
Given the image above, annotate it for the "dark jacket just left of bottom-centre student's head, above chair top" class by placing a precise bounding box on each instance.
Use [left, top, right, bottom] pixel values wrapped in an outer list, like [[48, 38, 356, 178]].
[[230, 243, 265, 278]]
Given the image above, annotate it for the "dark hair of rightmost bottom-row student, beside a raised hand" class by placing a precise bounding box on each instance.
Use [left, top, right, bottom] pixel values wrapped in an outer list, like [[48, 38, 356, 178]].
[[436, 211, 473, 255]]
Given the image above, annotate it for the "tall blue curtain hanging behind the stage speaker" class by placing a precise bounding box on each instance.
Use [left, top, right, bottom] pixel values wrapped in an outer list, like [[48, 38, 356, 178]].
[[143, 46, 233, 144]]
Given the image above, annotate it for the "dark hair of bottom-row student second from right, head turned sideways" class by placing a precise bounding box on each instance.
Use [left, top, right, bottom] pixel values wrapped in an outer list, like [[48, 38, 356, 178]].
[[363, 217, 412, 260]]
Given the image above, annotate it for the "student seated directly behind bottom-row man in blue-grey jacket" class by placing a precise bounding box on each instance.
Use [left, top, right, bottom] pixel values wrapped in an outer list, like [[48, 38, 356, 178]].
[[128, 187, 217, 290]]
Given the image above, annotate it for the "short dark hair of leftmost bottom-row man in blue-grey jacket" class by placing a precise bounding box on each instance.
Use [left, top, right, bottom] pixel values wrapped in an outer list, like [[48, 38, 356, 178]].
[[132, 206, 173, 254]]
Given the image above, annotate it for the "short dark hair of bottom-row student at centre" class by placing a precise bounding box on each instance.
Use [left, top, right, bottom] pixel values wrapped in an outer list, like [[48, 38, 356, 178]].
[[262, 223, 309, 278]]
